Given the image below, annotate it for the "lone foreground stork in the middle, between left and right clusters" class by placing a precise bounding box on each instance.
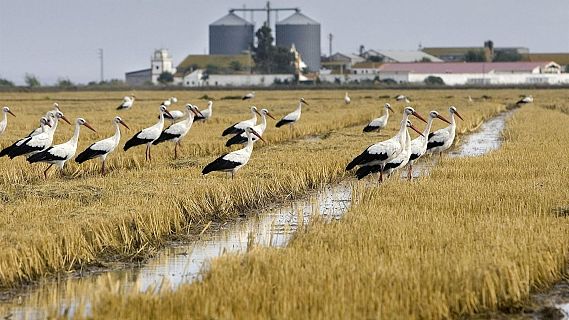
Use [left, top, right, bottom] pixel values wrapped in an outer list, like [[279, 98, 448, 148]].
[[202, 127, 265, 179]]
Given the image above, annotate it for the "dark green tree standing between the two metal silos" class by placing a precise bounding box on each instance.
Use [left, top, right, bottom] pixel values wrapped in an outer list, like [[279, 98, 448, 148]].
[[253, 24, 294, 73]]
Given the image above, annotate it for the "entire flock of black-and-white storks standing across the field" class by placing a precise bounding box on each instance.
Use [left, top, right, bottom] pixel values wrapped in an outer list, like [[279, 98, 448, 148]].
[[0, 92, 533, 182]]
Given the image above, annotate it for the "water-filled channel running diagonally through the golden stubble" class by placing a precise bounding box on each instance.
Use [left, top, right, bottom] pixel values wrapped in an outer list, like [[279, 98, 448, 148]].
[[0, 112, 524, 319]]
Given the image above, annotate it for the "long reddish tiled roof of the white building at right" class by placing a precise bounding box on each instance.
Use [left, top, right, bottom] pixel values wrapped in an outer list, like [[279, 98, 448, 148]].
[[379, 61, 549, 73]]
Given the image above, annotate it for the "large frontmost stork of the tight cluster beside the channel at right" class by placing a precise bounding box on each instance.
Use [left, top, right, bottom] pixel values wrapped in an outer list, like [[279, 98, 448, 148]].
[[346, 107, 427, 182]]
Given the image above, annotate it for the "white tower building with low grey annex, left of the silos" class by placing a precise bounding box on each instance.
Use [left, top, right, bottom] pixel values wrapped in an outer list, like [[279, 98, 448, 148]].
[[125, 49, 176, 87]]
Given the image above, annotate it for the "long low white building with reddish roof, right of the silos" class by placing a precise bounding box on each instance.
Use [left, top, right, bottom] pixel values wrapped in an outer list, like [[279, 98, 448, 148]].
[[379, 62, 569, 85]]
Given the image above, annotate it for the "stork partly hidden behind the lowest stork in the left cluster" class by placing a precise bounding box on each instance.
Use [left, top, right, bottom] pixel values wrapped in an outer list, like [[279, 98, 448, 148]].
[[0, 111, 71, 159]]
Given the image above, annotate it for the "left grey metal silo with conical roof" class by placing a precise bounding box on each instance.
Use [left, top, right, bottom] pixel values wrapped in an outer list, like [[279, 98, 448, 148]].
[[209, 12, 254, 55]]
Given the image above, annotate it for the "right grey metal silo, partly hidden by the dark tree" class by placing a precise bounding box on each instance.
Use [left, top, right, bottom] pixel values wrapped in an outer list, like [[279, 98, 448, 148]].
[[276, 12, 320, 71]]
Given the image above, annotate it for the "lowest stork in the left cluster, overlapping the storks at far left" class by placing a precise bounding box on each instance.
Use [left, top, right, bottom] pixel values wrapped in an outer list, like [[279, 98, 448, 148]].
[[27, 118, 97, 179]]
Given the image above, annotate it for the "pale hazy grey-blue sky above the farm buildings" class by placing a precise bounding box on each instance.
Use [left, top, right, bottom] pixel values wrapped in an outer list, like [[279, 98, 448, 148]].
[[0, 0, 569, 83]]
